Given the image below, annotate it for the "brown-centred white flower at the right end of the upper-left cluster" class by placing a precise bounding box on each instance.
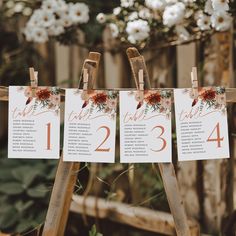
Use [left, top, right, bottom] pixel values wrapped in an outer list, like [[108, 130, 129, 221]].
[[69, 3, 89, 24]]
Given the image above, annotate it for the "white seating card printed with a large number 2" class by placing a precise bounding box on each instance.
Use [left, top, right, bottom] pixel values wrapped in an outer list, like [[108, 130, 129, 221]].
[[64, 89, 118, 163]]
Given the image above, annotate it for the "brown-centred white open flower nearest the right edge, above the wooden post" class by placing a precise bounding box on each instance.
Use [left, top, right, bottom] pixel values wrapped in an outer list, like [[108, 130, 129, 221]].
[[211, 11, 232, 31]]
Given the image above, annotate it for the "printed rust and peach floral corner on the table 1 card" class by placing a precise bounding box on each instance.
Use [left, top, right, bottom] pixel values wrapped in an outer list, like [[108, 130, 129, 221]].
[[17, 87, 61, 115]]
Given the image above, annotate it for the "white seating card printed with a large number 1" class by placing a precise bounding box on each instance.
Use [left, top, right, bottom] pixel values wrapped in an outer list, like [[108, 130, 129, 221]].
[[8, 86, 60, 159]]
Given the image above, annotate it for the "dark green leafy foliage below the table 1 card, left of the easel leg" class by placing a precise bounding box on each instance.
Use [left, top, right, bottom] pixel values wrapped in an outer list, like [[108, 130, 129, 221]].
[[0, 148, 56, 233]]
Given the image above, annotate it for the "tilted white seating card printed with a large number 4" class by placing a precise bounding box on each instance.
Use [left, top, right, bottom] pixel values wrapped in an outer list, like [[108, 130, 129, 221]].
[[174, 87, 229, 161]]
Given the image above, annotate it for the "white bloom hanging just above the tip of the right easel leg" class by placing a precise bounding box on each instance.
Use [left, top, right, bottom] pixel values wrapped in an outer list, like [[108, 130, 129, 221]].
[[126, 19, 150, 43]]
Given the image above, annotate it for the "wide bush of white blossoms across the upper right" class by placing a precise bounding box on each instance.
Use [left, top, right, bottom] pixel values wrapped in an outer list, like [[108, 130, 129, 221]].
[[97, 0, 232, 46]]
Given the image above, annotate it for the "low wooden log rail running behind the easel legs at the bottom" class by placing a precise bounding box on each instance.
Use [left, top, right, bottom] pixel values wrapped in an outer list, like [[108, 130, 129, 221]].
[[70, 195, 199, 236]]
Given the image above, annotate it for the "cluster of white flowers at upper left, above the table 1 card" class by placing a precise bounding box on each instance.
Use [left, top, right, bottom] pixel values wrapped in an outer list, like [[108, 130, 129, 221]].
[[24, 0, 89, 43]]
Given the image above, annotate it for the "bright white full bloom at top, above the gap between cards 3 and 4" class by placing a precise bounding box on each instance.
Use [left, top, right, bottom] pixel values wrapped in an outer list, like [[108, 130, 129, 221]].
[[163, 2, 185, 27]]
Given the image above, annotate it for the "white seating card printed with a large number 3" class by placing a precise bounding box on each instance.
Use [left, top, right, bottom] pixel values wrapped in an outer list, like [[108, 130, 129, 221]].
[[120, 90, 171, 163]]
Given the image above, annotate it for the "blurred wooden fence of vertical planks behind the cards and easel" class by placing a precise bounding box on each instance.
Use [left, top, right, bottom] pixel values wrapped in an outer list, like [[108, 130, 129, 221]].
[[0, 31, 236, 233]]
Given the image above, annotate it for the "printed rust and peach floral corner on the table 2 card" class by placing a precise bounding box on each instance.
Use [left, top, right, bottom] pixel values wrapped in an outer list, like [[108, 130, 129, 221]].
[[76, 90, 119, 119]]
